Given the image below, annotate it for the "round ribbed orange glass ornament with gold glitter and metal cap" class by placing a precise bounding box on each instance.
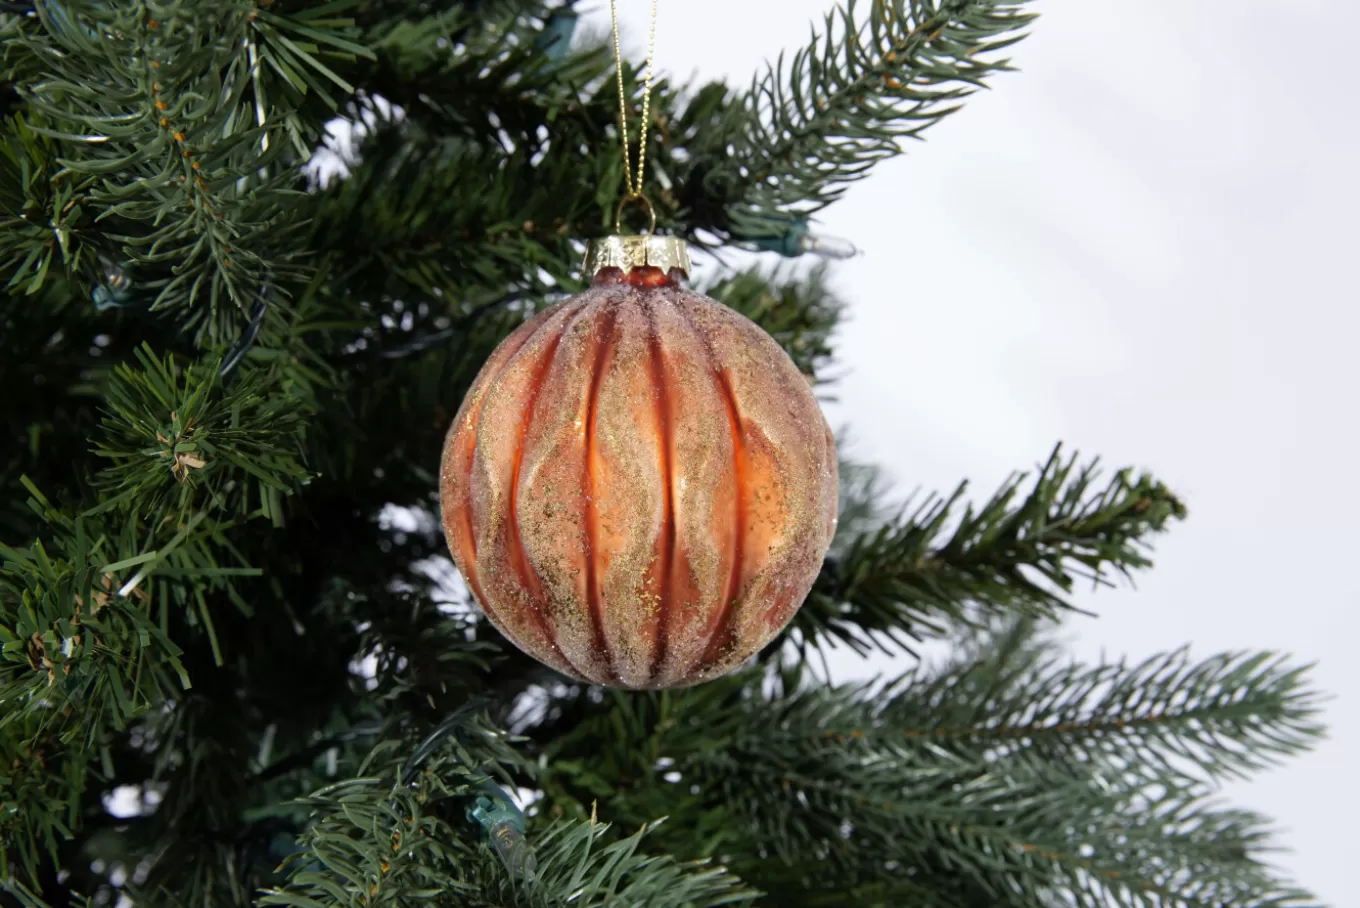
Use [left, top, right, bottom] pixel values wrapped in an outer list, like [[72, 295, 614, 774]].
[[439, 237, 838, 689]]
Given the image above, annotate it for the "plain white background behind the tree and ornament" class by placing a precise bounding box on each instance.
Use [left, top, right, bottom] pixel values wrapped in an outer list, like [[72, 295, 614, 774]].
[[598, 0, 1360, 905]]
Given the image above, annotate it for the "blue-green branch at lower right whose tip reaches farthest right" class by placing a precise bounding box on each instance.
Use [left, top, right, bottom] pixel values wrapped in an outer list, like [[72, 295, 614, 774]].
[[884, 623, 1322, 782]]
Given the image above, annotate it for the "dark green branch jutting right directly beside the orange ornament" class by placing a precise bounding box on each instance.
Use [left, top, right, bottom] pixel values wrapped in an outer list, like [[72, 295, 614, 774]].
[[794, 447, 1185, 654]]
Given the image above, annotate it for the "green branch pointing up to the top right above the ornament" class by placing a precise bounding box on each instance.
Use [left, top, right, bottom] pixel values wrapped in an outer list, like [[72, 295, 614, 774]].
[[710, 0, 1035, 238]]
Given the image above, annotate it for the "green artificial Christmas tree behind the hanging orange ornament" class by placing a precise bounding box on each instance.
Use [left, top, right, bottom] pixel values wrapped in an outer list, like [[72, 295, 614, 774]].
[[0, 0, 1321, 908]]
